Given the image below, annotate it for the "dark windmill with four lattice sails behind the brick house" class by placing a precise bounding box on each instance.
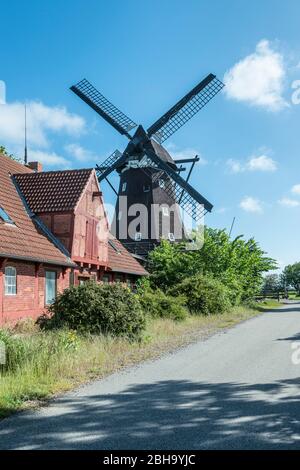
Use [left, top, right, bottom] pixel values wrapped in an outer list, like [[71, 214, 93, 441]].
[[71, 74, 224, 256]]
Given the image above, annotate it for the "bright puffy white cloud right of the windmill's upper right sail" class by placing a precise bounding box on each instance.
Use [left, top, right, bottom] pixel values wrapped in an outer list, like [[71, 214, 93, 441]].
[[224, 40, 287, 111]]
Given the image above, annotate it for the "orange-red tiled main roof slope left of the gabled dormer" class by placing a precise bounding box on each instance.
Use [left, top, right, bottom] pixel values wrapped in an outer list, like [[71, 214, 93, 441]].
[[0, 155, 74, 266]]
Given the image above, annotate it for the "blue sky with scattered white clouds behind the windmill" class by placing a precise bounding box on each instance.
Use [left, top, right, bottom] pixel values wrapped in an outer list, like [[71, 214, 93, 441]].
[[0, 0, 300, 265]]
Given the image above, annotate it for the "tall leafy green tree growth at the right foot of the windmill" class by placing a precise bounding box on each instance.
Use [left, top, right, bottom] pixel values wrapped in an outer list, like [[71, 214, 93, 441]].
[[148, 227, 276, 300]]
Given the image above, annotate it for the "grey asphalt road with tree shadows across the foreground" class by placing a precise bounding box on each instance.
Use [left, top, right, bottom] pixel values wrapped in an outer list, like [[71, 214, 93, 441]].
[[0, 304, 300, 450]]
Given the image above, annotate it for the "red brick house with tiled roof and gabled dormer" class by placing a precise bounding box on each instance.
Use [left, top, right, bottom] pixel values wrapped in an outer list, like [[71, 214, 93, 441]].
[[0, 155, 147, 324]]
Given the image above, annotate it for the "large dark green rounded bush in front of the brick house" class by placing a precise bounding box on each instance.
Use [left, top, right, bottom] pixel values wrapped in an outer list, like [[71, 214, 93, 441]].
[[42, 282, 145, 340]]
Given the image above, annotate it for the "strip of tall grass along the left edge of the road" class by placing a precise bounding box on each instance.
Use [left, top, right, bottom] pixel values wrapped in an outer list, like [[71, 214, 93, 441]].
[[0, 307, 266, 418]]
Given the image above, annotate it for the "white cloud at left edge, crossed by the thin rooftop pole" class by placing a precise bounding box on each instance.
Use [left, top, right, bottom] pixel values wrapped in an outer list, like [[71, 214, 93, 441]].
[[0, 101, 85, 147]]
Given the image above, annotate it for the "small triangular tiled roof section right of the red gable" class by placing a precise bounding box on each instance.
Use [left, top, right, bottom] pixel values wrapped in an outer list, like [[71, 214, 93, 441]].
[[108, 235, 148, 276]]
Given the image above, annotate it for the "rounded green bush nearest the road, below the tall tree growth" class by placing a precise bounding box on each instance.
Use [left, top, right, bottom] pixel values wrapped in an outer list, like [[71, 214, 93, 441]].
[[169, 274, 231, 315]]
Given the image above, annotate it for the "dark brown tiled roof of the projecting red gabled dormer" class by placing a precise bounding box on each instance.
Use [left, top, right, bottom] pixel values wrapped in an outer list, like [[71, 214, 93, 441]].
[[15, 169, 94, 214]]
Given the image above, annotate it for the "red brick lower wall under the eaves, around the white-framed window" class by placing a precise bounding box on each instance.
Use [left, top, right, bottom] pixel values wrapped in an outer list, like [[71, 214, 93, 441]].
[[0, 260, 69, 324]]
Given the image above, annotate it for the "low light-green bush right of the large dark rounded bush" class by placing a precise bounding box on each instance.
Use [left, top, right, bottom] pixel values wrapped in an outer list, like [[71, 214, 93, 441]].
[[139, 289, 188, 321]]
